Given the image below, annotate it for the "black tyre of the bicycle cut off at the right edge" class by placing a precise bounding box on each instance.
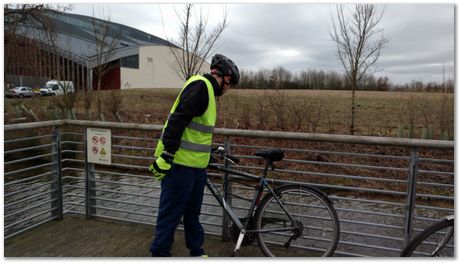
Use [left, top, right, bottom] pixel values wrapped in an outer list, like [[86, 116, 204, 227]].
[[401, 218, 454, 257]]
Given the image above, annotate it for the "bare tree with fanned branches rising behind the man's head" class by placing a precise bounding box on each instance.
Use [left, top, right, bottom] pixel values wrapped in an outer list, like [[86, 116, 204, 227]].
[[168, 4, 227, 81]]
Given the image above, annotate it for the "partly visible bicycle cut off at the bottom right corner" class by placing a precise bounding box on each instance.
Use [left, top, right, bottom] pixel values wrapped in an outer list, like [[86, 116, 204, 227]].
[[401, 215, 455, 257]]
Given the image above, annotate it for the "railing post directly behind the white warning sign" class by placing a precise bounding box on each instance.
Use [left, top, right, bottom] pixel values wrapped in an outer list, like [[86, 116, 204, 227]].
[[84, 127, 96, 219]]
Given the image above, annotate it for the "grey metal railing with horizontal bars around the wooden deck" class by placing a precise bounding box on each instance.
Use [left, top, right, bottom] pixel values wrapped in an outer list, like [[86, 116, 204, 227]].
[[4, 120, 454, 257]]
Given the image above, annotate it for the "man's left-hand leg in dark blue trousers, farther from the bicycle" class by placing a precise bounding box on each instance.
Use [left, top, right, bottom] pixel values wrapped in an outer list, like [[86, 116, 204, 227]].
[[150, 165, 193, 257]]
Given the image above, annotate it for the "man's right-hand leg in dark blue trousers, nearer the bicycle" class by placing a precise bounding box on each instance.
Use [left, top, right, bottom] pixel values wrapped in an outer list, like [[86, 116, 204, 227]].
[[184, 169, 208, 256]]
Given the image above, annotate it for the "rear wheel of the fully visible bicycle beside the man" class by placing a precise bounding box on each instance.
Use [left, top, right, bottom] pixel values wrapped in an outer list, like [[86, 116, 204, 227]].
[[256, 185, 340, 257]]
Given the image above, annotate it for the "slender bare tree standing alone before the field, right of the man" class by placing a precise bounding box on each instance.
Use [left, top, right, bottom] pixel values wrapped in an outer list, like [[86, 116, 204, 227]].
[[330, 4, 388, 134]]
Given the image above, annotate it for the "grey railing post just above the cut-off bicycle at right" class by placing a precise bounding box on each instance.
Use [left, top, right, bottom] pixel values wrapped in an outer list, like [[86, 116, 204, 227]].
[[404, 148, 418, 247]]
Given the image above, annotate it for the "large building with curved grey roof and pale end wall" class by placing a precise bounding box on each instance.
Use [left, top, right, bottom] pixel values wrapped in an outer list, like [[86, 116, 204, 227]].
[[4, 9, 209, 90]]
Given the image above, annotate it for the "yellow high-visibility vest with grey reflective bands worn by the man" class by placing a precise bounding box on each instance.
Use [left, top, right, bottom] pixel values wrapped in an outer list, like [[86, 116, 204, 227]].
[[155, 75, 217, 168]]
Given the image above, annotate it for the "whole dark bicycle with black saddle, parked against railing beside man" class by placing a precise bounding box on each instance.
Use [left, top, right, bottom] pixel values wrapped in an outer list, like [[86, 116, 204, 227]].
[[207, 147, 340, 257]]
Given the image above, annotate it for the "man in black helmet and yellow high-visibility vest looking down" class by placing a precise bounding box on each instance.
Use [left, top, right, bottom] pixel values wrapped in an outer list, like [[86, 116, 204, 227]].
[[149, 54, 240, 256]]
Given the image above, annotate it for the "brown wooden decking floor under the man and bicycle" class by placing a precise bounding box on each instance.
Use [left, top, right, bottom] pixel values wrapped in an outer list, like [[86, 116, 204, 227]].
[[4, 216, 263, 257]]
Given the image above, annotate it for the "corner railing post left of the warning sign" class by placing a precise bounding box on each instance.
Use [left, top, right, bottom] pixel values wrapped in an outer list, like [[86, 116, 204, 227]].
[[51, 126, 64, 220]]
